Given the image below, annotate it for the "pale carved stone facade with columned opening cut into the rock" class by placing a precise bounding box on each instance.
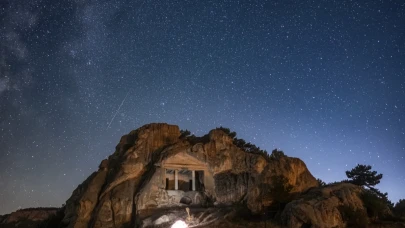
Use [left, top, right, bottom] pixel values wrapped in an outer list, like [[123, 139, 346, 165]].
[[137, 152, 215, 213]]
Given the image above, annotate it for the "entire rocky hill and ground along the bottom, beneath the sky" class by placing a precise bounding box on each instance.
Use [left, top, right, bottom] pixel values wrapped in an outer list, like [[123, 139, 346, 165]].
[[0, 123, 405, 228]]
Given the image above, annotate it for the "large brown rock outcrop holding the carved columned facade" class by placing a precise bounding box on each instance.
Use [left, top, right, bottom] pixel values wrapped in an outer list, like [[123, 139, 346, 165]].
[[62, 123, 318, 228]]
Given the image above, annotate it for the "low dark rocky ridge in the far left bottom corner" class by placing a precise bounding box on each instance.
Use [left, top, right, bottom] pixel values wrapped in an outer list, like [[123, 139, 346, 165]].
[[0, 208, 59, 227]]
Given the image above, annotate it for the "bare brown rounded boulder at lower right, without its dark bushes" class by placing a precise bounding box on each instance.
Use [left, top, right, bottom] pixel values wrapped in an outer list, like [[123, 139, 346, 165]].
[[282, 183, 366, 228]]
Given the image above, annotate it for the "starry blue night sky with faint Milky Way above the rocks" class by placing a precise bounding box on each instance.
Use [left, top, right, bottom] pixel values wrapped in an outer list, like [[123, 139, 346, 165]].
[[0, 0, 405, 214]]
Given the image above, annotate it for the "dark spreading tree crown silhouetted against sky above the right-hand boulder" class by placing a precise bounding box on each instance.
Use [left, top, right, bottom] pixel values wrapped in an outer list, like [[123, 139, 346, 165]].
[[346, 164, 383, 188]]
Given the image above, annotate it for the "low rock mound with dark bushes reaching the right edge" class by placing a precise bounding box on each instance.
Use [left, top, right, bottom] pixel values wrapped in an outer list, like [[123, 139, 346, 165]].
[[281, 182, 405, 228]]
